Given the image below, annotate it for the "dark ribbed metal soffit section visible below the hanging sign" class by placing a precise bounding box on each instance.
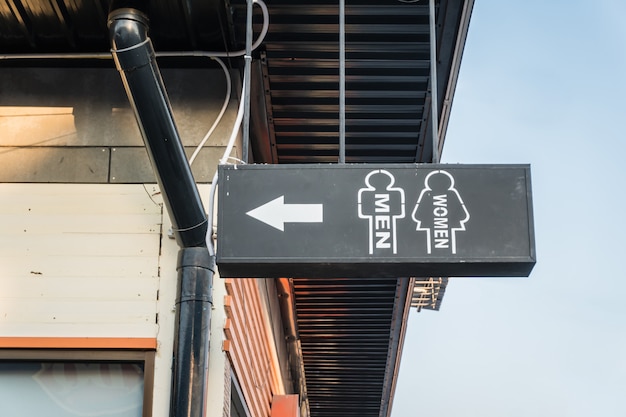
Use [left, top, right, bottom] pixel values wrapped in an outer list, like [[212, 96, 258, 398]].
[[293, 278, 410, 417]]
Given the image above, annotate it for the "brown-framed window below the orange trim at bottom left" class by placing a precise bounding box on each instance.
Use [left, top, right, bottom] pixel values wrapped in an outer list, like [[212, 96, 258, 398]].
[[0, 350, 154, 417]]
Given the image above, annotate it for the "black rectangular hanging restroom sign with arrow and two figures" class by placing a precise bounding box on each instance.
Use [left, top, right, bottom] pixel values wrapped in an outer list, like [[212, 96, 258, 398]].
[[217, 164, 535, 278]]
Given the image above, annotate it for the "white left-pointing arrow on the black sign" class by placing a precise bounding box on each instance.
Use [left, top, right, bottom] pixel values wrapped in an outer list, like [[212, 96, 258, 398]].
[[246, 195, 324, 232]]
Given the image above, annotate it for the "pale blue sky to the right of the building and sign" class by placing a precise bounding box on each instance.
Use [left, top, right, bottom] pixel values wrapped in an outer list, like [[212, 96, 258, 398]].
[[392, 0, 626, 417]]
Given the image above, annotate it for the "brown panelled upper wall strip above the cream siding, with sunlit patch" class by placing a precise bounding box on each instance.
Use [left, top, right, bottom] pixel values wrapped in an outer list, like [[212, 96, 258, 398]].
[[0, 67, 237, 184]]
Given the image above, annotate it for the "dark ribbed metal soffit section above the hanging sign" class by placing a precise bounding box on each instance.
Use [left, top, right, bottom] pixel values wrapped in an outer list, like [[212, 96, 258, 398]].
[[233, 0, 473, 163]]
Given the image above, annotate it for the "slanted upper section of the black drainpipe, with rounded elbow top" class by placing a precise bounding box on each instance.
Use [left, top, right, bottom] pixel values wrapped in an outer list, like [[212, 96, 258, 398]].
[[109, 8, 207, 247]]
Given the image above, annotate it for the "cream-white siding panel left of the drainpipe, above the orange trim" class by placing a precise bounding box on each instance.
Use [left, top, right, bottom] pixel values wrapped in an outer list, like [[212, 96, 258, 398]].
[[0, 184, 163, 337]]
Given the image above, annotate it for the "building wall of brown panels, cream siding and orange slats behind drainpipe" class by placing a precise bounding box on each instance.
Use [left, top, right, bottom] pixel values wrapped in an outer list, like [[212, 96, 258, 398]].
[[0, 68, 291, 417]]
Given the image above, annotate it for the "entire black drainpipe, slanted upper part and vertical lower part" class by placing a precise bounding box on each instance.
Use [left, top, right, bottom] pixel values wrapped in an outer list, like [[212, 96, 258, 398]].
[[108, 8, 215, 417]]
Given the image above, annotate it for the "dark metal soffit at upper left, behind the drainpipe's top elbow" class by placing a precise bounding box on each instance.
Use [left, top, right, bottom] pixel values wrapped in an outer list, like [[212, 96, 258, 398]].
[[0, 0, 230, 54]]
